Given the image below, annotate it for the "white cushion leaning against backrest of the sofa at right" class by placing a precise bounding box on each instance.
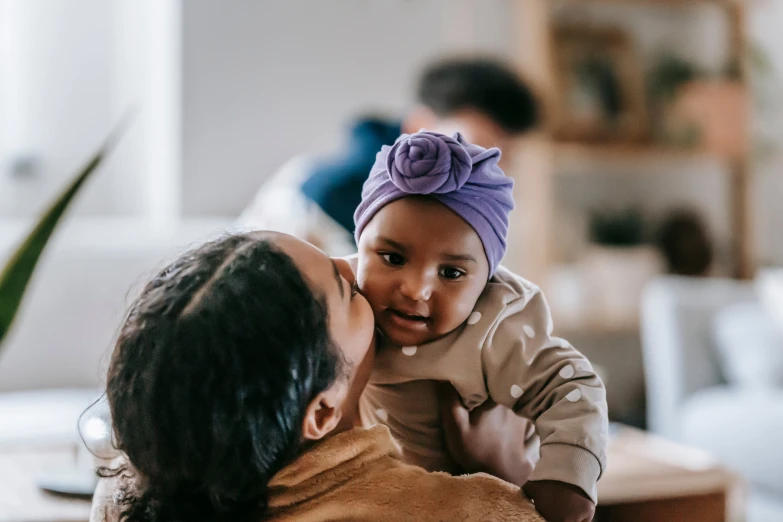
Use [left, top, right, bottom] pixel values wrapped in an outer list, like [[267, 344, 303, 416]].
[[713, 302, 783, 388]]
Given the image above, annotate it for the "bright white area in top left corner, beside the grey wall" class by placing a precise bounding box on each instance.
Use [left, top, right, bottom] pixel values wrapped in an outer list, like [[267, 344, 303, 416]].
[[0, 0, 181, 221]]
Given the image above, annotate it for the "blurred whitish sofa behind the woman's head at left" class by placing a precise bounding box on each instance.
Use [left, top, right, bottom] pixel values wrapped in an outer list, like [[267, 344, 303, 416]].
[[0, 218, 231, 445]]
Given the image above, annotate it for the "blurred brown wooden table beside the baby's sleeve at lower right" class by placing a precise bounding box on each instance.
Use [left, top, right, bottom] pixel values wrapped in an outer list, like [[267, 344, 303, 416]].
[[596, 427, 745, 522]]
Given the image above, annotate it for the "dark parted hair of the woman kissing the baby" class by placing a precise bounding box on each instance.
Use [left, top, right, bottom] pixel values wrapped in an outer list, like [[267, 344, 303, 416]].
[[107, 235, 344, 522]]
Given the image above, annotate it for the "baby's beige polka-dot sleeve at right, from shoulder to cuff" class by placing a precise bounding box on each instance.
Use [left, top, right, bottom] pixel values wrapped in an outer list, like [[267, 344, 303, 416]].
[[482, 284, 608, 503]]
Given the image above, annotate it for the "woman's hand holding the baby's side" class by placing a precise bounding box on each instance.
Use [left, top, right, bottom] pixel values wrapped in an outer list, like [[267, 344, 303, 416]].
[[438, 383, 533, 486]]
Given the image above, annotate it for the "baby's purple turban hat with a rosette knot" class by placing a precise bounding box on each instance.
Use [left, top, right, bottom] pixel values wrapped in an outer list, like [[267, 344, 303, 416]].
[[353, 131, 514, 277]]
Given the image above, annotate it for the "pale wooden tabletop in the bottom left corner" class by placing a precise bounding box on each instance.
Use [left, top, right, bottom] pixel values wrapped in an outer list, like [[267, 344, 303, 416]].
[[0, 445, 90, 522]]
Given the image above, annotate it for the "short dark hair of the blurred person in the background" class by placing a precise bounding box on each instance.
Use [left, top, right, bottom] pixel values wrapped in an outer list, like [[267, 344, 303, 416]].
[[417, 58, 540, 134]]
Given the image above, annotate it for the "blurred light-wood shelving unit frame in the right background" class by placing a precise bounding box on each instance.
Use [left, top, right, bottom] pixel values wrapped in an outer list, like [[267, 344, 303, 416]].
[[510, 0, 756, 331]]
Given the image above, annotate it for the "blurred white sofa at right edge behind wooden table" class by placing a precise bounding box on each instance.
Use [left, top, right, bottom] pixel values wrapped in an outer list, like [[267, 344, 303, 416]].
[[641, 277, 783, 522]]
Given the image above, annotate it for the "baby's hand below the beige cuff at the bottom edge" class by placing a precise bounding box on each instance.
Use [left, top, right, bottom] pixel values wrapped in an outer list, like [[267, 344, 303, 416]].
[[522, 480, 595, 522]]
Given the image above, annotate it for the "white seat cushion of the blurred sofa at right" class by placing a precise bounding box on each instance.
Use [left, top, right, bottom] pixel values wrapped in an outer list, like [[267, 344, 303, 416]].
[[680, 387, 783, 494]]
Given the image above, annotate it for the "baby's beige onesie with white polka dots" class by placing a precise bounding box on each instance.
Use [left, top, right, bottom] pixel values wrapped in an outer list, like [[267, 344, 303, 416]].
[[361, 266, 608, 502]]
